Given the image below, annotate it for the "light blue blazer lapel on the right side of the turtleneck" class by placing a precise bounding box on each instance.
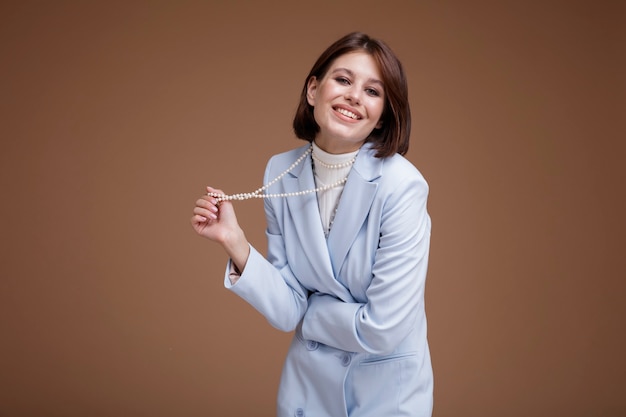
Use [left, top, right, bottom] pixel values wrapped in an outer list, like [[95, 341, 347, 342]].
[[328, 143, 383, 274]]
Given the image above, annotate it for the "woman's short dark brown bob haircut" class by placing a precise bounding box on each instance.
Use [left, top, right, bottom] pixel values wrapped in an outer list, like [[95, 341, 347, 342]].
[[293, 32, 411, 158]]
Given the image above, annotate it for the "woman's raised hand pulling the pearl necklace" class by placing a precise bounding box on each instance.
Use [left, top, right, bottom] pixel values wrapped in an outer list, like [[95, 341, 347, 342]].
[[191, 187, 250, 271]]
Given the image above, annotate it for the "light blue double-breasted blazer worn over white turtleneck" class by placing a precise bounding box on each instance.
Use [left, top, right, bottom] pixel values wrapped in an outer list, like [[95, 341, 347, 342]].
[[224, 144, 433, 417]]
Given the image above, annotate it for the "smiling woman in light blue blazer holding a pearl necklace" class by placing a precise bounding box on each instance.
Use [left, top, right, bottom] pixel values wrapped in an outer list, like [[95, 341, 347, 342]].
[[191, 33, 433, 417]]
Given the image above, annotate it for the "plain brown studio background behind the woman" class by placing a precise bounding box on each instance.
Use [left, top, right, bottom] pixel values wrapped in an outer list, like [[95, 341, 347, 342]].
[[0, 1, 626, 417]]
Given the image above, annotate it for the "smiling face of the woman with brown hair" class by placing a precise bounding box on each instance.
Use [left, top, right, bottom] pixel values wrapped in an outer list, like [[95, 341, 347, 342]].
[[307, 51, 385, 153]]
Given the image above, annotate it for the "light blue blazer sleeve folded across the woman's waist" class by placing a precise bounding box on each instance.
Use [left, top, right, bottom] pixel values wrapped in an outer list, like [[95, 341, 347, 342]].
[[302, 175, 431, 354]]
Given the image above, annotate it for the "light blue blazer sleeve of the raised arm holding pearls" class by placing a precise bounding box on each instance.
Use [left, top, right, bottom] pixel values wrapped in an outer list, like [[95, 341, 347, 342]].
[[224, 156, 308, 332]]
